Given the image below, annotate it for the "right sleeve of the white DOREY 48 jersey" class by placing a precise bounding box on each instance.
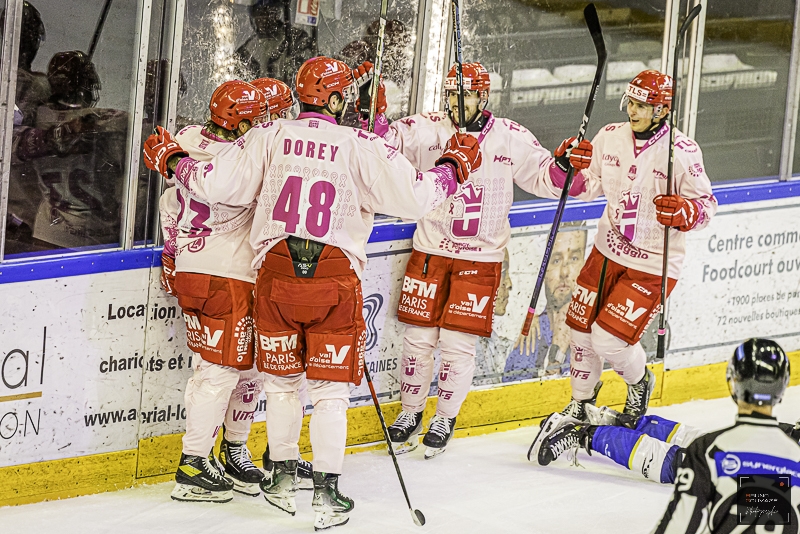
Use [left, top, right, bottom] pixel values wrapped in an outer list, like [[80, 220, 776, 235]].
[[358, 134, 456, 220]]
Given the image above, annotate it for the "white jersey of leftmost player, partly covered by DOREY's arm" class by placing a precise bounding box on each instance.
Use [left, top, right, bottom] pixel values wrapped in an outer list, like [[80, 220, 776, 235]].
[[170, 126, 256, 283]]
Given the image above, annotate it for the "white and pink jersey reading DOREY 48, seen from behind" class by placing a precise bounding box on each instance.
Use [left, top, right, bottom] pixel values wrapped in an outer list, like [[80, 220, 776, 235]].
[[176, 113, 455, 276]]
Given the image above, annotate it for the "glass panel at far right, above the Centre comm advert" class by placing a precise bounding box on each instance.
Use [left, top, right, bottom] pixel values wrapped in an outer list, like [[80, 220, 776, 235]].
[[695, 0, 794, 181]]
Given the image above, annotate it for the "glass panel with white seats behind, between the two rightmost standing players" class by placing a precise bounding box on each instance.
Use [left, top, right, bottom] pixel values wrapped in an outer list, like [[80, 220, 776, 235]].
[[463, 0, 666, 200]]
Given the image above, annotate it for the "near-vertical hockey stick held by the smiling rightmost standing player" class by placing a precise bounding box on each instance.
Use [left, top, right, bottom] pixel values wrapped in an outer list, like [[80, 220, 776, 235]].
[[656, 4, 703, 360]]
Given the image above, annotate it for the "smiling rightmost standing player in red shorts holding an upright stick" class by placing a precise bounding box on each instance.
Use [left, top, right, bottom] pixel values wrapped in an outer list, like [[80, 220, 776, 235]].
[[532, 70, 717, 426]]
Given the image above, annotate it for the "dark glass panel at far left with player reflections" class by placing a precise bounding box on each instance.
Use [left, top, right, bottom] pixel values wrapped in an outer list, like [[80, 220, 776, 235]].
[[5, 0, 137, 259]]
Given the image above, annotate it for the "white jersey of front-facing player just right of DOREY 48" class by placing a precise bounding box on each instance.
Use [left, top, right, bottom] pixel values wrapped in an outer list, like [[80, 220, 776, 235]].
[[385, 111, 552, 262]]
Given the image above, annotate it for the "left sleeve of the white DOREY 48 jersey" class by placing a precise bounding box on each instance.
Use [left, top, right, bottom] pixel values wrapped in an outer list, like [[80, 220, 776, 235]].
[[175, 123, 276, 206]]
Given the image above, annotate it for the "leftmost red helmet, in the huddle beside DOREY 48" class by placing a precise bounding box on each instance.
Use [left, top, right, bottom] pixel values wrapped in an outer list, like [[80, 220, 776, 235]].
[[208, 80, 267, 130]]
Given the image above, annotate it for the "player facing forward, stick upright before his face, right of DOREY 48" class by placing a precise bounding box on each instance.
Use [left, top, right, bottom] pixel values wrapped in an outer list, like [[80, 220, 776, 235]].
[[358, 63, 591, 458]]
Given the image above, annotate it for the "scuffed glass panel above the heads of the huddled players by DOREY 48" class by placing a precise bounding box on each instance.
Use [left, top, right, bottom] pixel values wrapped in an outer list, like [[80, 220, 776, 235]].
[[178, 0, 419, 127]]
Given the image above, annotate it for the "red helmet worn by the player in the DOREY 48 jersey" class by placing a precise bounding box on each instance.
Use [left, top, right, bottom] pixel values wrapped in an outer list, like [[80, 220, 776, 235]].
[[297, 56, 358, 107]]
